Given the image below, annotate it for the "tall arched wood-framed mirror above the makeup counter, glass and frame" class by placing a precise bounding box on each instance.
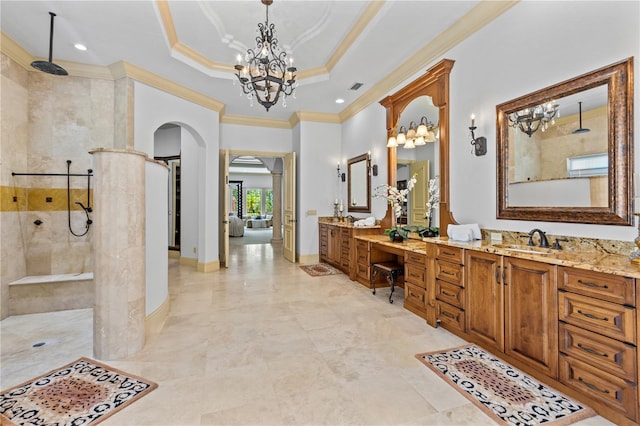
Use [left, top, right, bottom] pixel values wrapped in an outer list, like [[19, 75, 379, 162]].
[[380, 59, 456, 236]]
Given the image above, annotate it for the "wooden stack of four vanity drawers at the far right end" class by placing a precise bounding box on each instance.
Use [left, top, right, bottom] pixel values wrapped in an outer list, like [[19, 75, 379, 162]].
[[558, 267, 640, 422]]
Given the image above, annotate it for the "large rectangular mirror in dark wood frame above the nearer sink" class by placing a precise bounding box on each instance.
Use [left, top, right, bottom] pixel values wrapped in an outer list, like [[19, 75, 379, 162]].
[[496, 58, 633, 225]]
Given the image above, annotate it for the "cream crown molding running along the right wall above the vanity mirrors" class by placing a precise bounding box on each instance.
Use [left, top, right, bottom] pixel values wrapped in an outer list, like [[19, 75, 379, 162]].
[[339, 0, 520, 122]]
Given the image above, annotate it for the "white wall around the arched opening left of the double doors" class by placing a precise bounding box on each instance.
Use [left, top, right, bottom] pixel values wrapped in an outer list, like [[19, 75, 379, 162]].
[[134, 82, 220, 263]]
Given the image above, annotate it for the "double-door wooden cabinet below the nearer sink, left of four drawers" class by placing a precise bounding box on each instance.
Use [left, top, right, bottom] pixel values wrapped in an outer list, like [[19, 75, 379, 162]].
[[465, 250, 558, 378]]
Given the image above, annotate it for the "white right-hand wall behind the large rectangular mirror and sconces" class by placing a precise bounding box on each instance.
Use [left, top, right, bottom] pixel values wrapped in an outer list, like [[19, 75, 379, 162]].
[[343, 1, 640, 241]]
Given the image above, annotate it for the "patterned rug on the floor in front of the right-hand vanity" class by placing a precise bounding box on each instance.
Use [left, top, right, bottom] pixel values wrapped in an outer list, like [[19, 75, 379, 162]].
[[416, 345, 595, 426]]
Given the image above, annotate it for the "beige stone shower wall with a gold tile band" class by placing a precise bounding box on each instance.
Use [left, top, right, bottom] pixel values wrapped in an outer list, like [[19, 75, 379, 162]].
[[0, 54, 115, 318]]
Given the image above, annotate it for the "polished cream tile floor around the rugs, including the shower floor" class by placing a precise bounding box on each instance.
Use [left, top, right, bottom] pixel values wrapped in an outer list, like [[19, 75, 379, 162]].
[[0, 244, 611, 426]]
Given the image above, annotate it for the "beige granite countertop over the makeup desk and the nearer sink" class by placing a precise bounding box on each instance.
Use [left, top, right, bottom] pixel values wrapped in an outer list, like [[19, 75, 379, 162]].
[[356, 235, 640, 278]]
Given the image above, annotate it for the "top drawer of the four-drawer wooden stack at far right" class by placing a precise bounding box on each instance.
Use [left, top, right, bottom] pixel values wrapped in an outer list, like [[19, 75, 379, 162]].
[[558, 267, 636, 306]]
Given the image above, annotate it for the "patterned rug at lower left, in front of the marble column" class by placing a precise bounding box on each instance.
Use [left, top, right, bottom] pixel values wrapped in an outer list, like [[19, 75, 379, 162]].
[[0, 358, 158, 426]]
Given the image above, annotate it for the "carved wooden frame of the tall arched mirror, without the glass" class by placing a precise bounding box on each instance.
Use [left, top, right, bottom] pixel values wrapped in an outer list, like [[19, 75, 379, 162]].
[[380, 59, 456, 236]]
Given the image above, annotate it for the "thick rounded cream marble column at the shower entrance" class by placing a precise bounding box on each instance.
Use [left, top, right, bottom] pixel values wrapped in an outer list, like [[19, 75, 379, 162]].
[[90, 148, 146, 360]]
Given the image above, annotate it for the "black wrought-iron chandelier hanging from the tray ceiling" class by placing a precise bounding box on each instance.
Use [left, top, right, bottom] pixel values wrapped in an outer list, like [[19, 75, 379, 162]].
[[234, 0, 298, 111]]
